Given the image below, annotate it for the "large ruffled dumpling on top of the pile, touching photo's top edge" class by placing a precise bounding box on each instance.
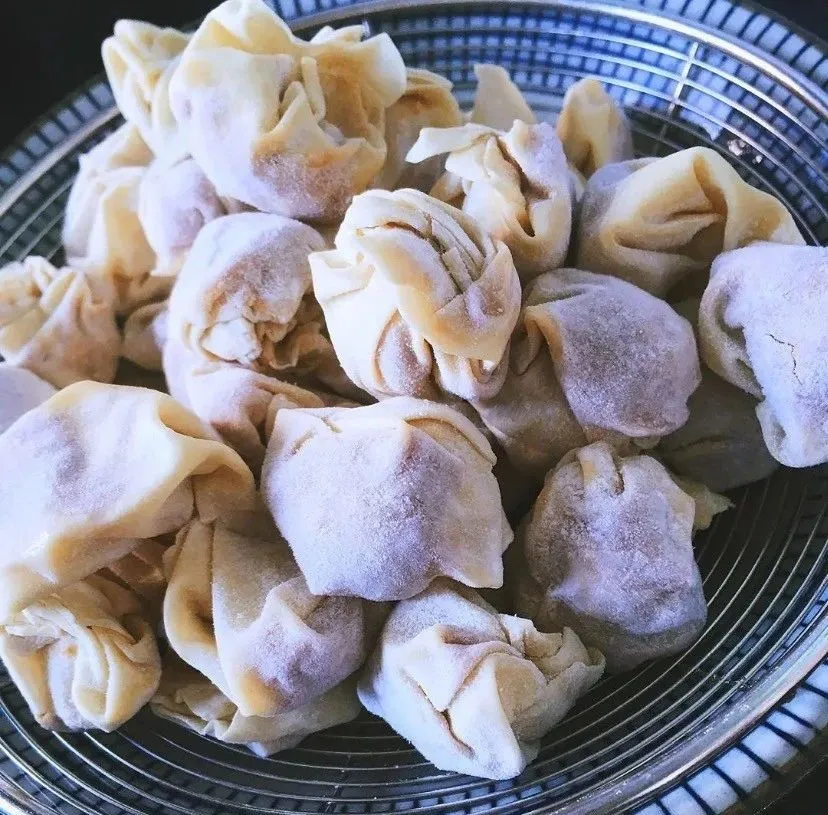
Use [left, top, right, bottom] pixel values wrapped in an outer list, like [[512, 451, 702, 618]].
[[170, 0, 406, 222]]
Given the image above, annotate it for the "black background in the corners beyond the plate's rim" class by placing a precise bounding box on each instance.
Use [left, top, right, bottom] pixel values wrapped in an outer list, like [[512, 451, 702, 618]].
[[0, 0, 828, 815]]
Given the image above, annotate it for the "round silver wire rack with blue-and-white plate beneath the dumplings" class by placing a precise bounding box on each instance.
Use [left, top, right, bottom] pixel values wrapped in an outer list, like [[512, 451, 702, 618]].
[[0, 0, 828, 815]]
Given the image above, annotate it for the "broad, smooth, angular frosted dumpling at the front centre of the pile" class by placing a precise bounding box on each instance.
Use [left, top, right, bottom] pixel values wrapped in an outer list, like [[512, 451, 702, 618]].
[[262, 397, 512, 600]]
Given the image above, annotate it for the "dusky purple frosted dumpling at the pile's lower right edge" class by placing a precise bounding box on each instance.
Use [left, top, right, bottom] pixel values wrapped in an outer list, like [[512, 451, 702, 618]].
[[515, 442, 707, 671]]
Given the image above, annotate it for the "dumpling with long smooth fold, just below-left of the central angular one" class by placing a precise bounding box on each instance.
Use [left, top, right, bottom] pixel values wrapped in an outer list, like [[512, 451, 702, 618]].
[[164, 513, 384, 716]]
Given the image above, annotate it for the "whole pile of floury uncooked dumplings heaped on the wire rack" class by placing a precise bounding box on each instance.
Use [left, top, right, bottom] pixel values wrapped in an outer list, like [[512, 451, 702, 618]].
[[0, 0, 828, 779]]
